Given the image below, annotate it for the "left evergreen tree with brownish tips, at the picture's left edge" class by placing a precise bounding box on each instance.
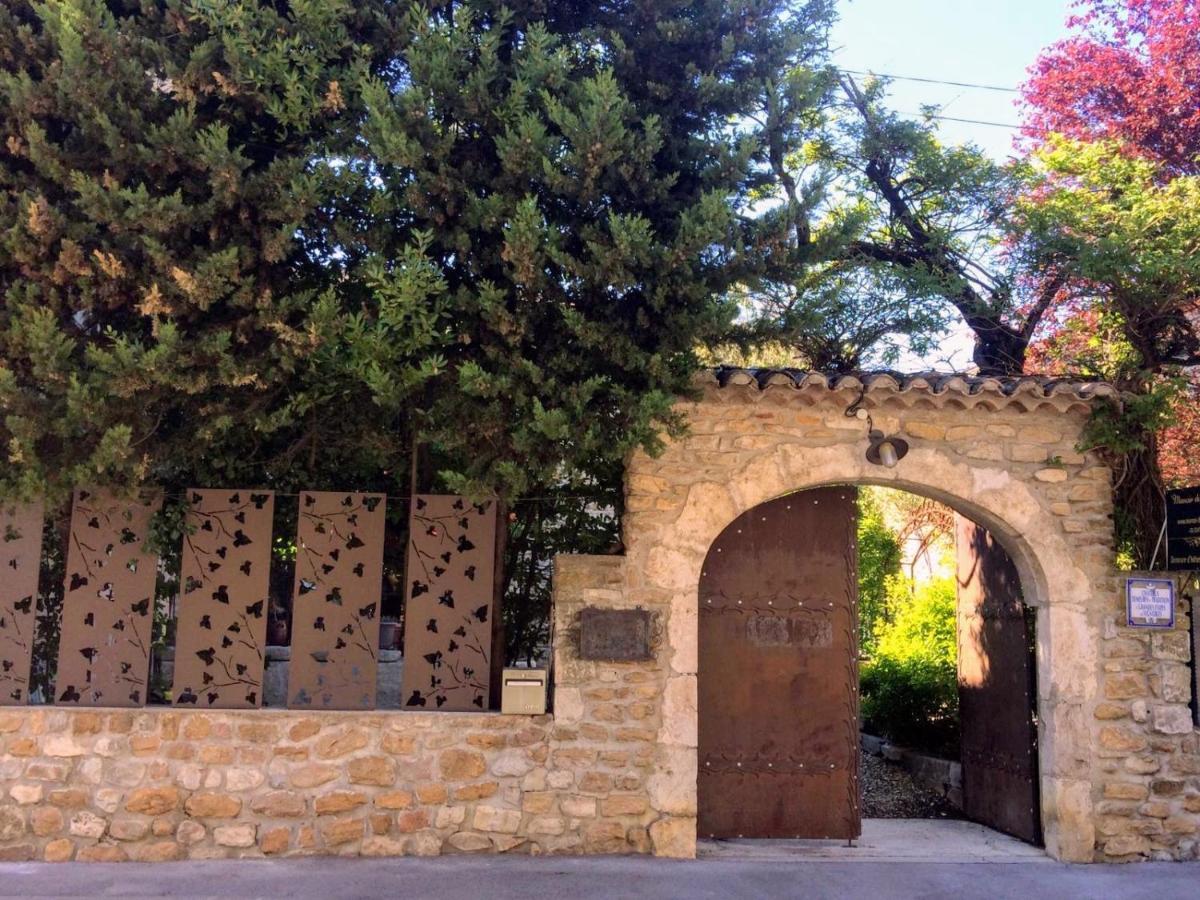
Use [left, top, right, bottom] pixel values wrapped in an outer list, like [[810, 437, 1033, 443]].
[[0, 0, 427, 503]]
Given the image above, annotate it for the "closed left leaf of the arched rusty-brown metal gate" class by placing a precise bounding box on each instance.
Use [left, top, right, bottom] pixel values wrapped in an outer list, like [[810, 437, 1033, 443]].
[[697, 487, 860, 839]]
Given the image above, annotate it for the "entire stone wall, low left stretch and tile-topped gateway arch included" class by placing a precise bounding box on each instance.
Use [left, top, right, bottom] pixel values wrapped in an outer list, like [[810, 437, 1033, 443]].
[[0, 382, 1200, 862]]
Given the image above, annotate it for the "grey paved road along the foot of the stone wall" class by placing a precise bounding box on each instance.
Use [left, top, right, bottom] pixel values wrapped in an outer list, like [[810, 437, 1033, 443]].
[[0, 857, 1200, 900]]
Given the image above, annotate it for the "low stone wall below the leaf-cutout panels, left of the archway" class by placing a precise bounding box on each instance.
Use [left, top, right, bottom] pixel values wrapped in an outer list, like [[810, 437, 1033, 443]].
[[0, 557, 694, 860]]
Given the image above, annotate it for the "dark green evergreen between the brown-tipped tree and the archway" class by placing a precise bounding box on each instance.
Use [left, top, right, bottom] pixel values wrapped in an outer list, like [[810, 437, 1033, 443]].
[[348, 1, 828, 496]]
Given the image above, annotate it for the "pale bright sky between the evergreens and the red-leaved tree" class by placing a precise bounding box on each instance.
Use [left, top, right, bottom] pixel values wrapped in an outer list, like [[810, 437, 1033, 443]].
[[833, 0, 1070, 371]]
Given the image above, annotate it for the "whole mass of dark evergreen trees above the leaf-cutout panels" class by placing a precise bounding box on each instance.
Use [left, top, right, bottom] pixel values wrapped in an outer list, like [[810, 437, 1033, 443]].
[[0, 0, 832, 502]]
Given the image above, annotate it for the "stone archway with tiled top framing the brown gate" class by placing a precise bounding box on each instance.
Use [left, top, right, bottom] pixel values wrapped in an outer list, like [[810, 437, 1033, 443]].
[[625, 378, 1114, 862]]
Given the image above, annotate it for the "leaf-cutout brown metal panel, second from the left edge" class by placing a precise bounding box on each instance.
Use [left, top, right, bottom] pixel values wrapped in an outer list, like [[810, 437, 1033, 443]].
[[54, 490, 162, 707]]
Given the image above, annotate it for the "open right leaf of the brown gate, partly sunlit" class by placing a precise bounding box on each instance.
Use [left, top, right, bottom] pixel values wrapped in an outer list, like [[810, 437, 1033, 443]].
[[955, 516, 1042, 844]]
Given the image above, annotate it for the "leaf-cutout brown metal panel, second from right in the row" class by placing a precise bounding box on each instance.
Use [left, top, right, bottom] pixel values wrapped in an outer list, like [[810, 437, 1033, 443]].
[[288, 491, 385, 709]]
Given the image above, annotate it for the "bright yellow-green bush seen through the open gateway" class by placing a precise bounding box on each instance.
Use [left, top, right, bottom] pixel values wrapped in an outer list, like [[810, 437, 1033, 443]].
[[860, 576, 959, 756]]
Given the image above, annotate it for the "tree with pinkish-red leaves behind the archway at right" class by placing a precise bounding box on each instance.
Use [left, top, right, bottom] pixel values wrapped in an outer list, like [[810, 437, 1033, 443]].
[[1024, 0, 1200, 501]]
